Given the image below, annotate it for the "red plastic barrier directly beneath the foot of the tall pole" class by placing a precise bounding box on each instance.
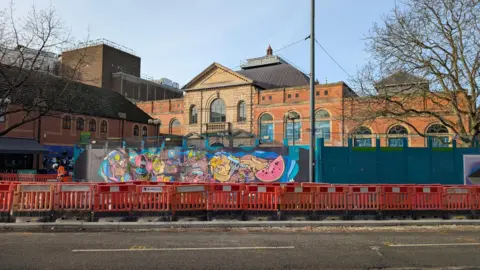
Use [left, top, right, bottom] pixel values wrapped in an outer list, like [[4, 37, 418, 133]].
[[280, 185, 318, 211]]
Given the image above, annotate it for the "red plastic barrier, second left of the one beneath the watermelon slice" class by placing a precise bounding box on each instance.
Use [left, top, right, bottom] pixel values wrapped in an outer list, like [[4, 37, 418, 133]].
[[172, 184, 209, 211]]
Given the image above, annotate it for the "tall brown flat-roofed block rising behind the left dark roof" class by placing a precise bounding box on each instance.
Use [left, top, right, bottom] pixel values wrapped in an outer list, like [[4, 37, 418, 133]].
[[61, 39, 183, 102]]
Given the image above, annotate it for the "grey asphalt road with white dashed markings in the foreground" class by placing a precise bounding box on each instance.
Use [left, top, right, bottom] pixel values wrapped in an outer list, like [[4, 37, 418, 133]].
[[0, 231, 480, 270]]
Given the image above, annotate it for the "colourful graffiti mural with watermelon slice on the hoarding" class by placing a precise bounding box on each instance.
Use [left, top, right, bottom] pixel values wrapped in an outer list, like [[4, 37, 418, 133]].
[[98, 146, 298, 183]]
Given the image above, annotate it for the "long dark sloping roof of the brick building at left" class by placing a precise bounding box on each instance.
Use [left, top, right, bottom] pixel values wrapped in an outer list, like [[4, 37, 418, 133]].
[[0, 69, 151, 123]]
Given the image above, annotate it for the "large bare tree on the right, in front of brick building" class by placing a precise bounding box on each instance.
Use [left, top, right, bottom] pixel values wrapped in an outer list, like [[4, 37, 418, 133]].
[[349, 0, 480, 145]]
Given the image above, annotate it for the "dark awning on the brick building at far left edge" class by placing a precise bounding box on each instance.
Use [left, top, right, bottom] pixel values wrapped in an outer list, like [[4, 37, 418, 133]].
[[0, 137, 48, 154]]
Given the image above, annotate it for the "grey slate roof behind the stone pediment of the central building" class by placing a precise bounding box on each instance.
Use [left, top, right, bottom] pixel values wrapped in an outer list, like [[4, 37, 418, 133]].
[[236, 64, 310, 89]]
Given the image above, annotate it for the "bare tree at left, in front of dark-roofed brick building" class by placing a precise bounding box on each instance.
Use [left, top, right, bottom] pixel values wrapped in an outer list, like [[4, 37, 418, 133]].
[[0, 2, 86, 136]]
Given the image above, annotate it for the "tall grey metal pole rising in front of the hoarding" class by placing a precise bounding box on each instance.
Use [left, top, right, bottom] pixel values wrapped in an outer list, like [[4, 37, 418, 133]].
[[308, 0, 315, 183]]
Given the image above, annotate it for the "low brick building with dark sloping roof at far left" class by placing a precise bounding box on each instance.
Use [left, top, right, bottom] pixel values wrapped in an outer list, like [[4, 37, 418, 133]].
[[0, 73, 156, 170]]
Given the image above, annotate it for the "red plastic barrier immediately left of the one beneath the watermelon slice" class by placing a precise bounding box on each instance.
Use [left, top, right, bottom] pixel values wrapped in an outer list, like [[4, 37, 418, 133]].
[[208, 184, 243, 211]]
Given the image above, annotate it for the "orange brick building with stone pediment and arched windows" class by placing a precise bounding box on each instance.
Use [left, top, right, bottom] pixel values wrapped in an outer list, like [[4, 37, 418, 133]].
[[137, 46, 453, 146]]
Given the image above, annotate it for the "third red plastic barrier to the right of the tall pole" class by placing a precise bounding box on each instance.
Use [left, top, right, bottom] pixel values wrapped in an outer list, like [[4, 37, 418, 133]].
[[380, 186, 413, 210]]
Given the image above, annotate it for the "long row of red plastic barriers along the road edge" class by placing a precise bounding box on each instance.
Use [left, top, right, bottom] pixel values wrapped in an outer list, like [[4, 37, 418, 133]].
[[0, 181, 480, 221]]
